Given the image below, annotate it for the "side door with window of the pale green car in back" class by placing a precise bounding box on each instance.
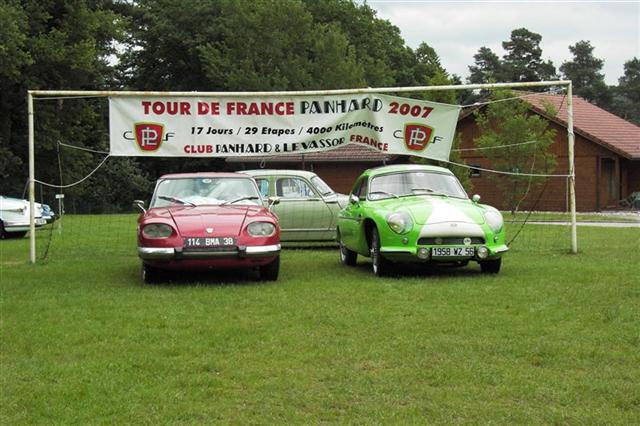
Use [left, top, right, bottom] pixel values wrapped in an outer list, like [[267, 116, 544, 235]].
[[273, 176, 333, 241]]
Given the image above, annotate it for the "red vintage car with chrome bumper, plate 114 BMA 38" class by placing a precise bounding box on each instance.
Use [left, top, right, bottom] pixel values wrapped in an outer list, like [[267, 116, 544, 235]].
[[135, 173, 280, 282]]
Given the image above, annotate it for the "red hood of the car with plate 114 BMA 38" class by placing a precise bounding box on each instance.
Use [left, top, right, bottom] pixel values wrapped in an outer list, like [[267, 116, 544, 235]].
[[154, 206, 264, 237]]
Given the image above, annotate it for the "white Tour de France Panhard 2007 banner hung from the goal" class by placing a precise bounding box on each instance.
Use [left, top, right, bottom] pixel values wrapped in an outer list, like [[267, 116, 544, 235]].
[[109, 94, 461, 160]]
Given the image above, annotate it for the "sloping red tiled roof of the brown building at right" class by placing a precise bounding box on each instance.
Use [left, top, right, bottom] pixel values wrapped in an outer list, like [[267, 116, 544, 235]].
[[524, 93, 640, 159]]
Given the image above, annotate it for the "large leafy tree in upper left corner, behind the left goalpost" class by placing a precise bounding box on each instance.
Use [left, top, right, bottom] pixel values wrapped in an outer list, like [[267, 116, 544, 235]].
[[0, 0, 136, 206]]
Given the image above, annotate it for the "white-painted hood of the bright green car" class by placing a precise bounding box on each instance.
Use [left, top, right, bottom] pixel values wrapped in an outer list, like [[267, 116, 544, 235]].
[[382, 195, 484, 225]]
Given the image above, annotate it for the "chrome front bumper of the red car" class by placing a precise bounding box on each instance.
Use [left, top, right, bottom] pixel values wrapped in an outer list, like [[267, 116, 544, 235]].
[[138, 244, 280, 260]]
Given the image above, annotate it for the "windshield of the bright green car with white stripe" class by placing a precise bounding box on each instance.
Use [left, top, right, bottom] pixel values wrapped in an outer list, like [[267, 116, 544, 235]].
[[368, 171, 468, 201]]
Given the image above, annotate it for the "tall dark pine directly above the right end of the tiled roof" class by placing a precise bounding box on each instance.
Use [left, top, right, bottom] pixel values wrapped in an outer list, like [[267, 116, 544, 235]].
[[560, 40, 611, 107]]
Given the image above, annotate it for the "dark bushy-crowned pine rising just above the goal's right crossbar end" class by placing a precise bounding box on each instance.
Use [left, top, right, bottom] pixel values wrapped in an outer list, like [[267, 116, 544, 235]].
[[502, 28, 556, 82]]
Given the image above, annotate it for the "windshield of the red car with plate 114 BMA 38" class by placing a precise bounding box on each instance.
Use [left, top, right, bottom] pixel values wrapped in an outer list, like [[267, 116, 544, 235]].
[[150, 177, 262, 208]]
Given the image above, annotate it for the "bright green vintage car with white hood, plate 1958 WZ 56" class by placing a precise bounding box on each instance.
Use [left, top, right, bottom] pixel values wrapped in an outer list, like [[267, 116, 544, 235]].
[[337, 165, 508, 276]]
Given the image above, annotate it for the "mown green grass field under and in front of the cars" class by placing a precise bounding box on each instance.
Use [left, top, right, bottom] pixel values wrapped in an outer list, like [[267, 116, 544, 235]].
[[0, 218, 640, 425]]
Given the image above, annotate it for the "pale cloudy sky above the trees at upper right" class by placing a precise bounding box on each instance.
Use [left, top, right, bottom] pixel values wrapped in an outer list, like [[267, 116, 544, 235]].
[[366, 0, 640, 85]]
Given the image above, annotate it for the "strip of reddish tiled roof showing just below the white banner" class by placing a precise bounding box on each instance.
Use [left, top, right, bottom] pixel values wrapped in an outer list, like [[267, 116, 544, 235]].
[[227, 143, 396, 163]]
